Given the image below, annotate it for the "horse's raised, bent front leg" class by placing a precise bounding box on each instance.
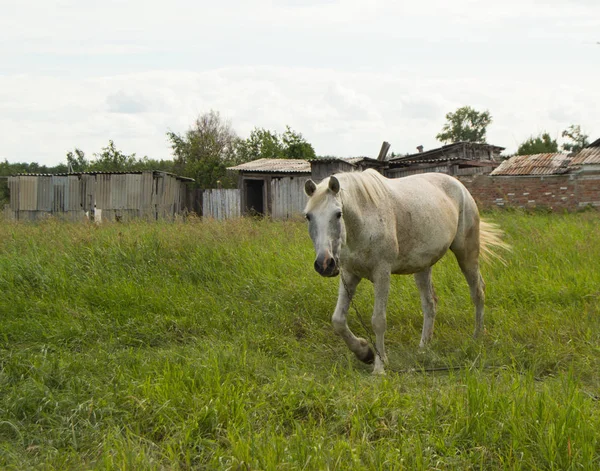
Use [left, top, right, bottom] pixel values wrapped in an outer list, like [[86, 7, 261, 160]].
[[331, 271, 374, 363]]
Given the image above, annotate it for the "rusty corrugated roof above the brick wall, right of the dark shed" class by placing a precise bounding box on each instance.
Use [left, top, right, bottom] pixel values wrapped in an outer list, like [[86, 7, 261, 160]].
[[490, 152, 571, 176]]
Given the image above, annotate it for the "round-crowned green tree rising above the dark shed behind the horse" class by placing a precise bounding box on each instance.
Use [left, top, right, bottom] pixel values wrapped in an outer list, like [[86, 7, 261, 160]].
[[436, 106, 492, 144]]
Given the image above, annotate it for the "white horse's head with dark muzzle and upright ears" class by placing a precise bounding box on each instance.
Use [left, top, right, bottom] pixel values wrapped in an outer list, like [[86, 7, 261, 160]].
[[304, 176, 346, 276]]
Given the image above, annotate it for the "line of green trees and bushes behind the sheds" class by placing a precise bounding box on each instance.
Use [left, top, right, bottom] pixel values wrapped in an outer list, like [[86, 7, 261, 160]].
[[0, 106, 589, 209]]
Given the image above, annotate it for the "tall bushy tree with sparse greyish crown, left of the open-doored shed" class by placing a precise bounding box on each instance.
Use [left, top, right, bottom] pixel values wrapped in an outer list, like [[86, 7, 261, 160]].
[[167, 110, 238, 188]]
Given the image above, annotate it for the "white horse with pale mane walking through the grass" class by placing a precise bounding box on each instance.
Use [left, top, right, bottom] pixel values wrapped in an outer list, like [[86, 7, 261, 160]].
[[304, 170, 508, 374]]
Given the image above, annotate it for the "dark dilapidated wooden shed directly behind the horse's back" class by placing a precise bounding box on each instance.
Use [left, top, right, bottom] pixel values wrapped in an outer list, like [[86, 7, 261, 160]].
[[385, 142, 504, 178]]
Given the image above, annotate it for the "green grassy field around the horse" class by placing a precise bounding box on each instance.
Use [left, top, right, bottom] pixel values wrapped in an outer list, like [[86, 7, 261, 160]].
[[0, 212, 600, 470]]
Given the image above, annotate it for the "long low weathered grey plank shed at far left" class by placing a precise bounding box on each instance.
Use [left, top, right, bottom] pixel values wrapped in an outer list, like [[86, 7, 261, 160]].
[[7, 171, 194, 221]]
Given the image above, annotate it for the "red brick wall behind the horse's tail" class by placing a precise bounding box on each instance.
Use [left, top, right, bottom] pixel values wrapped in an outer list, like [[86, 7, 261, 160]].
[[460, 173, 600, 211]]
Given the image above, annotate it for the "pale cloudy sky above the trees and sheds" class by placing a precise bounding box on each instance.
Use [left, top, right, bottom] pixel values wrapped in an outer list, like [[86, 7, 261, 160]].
[[0, 0, 600, 165]]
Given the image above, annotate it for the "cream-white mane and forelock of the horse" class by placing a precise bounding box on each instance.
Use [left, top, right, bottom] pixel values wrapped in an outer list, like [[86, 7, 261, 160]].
[[307, 169, 388, 211]]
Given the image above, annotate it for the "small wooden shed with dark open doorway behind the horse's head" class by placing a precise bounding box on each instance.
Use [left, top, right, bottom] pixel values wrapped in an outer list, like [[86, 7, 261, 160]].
[[228, 159, 311, 219]]
